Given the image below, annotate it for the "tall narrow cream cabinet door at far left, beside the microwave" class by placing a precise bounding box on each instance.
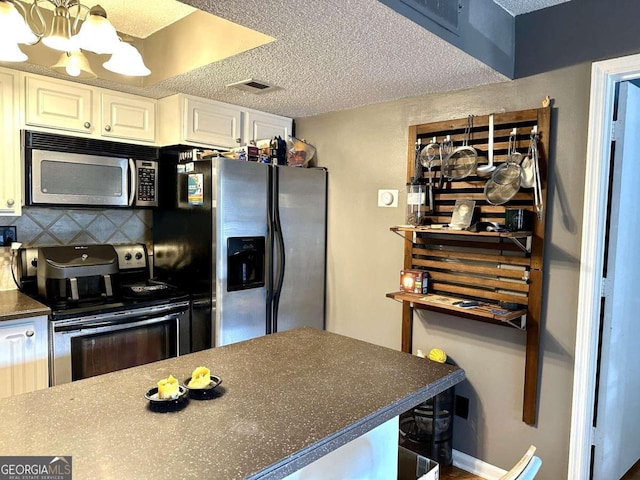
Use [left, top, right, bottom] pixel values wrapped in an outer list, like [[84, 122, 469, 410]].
[[0, 73, 22, 216]]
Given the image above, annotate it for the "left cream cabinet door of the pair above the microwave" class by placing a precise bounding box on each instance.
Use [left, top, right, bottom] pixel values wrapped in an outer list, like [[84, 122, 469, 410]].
[[25, 77, 94, 133]]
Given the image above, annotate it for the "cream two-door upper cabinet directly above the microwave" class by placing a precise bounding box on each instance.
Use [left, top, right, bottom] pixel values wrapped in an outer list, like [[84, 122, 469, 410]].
[[23, 74, 157, 143]]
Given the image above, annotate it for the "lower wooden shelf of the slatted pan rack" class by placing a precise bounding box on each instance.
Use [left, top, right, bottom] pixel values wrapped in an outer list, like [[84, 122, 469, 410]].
[[387, 292, 527, 330]]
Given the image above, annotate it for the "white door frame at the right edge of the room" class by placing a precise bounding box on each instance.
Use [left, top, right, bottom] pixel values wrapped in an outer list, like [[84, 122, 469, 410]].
[[567, 51, 640, 479]]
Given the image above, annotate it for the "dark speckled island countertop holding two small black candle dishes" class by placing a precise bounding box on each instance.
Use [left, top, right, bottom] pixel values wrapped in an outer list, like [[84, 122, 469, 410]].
[[0, 328, 464, 480]]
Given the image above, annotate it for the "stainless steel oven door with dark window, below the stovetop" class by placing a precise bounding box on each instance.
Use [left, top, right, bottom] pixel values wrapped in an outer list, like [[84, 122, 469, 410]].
[[49, 302, 190, 385]]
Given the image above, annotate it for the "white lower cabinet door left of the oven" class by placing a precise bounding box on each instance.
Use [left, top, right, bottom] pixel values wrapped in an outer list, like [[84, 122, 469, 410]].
[[0, 316, 49, 398]]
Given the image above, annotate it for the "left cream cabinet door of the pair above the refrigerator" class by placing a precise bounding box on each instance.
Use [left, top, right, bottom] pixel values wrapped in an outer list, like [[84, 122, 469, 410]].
[[184, 98, 241, 148]]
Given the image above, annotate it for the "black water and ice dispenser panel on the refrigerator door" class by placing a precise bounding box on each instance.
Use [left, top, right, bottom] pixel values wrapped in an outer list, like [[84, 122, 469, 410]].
[[227, 237, 266, 292]]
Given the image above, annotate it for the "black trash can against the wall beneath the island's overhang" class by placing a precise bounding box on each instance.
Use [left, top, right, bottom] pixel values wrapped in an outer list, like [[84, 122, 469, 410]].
[[399, 387, 455, 465]]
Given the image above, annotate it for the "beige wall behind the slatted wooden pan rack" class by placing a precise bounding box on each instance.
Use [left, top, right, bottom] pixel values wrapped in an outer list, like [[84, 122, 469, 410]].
[[296, 64, 590, 480]]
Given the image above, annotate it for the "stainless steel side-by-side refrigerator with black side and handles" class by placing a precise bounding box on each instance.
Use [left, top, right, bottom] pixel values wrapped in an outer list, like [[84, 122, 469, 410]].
[[152, 146, 327, 351]]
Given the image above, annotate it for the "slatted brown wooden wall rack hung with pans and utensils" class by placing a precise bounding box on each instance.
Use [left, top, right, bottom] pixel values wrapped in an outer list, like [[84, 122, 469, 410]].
[[387, 106, 551, 425]]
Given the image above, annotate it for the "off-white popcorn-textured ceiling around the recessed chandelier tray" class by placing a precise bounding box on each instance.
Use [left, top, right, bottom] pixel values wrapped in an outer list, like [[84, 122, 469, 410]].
[[7, 0, 565, 118]]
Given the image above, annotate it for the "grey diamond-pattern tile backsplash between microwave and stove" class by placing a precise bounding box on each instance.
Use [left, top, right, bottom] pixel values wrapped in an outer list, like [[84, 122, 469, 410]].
[[0, 207, 153, 290]]
